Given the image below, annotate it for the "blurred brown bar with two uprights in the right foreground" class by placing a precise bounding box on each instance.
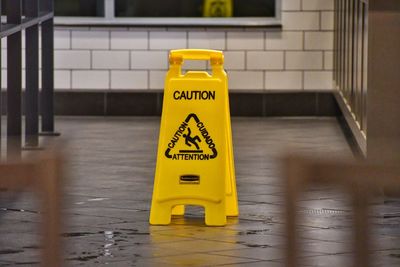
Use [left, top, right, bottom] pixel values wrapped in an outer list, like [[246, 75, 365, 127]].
[[283, 155, 400, 267]]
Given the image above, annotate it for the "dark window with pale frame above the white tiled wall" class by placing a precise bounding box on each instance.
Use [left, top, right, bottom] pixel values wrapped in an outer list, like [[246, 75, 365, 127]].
[[55, 0, 282, 26]]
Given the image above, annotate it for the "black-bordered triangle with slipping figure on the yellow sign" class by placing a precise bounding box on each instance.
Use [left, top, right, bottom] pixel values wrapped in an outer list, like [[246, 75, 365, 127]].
[[165, 113, 218, 160]]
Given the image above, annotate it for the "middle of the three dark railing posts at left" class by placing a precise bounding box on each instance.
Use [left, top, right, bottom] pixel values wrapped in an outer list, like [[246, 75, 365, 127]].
[[24, 0, 39, 149]]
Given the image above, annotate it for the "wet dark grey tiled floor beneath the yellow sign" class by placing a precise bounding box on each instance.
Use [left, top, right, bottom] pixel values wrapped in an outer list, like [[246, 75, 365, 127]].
[[0, 117, 400, 267]]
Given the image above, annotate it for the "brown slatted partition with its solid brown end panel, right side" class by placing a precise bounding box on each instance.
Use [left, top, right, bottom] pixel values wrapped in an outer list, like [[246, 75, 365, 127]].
[[334, 0, 400, 162]]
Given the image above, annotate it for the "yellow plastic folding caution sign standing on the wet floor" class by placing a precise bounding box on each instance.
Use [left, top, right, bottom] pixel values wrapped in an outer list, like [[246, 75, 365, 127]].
[[150, 49, 239, 226]]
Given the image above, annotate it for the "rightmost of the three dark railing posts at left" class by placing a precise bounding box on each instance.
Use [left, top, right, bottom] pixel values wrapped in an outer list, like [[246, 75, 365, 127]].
[[40, 0, 59, 136]]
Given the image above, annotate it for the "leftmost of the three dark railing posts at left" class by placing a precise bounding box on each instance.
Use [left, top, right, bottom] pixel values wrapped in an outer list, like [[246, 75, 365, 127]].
[[6, 0, 22, 157]]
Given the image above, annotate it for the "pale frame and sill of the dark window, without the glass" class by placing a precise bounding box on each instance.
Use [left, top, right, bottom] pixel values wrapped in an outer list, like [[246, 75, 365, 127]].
[[54, 0, 282, 27]]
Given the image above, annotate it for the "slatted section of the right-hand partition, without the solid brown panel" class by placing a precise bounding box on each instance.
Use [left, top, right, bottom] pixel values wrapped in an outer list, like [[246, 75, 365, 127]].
[[334, 0, 368, 155]]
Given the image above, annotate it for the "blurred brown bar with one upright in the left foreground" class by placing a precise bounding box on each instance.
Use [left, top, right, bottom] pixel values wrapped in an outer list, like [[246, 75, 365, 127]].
[[0, 148, 64, 267]]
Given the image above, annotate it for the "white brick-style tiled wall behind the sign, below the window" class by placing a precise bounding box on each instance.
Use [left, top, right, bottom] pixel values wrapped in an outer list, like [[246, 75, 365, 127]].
[[2, 0, 333, 91]]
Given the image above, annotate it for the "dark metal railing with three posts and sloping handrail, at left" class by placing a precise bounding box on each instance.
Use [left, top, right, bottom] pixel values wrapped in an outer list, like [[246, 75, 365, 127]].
[[0, 0, 56, 156]]
